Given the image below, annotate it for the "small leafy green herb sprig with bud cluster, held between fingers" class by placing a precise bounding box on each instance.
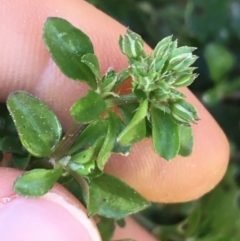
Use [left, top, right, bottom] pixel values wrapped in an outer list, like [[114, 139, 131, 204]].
[[0, 17, 199, 240]]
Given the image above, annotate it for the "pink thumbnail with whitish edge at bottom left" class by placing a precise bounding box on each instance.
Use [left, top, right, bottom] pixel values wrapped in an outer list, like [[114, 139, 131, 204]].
[[0, 192, 101, 241]]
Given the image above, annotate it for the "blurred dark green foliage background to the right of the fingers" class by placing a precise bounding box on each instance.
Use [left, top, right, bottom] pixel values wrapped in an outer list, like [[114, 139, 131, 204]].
[[88, 0, 240, 241]]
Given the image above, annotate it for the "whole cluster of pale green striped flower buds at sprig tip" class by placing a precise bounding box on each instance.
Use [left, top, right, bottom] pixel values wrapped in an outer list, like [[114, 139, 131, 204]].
[[119, 30, 199, 125]]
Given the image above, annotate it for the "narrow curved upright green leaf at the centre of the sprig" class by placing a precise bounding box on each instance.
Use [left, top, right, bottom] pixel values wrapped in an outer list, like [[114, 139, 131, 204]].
[[97, 111, 116, 170]]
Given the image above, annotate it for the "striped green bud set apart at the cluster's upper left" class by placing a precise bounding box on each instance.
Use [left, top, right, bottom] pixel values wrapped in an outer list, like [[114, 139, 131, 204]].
[[119, 29, 145, 59]]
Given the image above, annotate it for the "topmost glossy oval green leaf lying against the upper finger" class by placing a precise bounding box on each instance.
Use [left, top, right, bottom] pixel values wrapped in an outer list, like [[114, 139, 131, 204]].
[[43, 17, 97, 89]]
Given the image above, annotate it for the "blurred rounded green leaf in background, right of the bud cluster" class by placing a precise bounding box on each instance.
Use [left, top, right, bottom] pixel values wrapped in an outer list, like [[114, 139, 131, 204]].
[[204, 43, 234, 82]]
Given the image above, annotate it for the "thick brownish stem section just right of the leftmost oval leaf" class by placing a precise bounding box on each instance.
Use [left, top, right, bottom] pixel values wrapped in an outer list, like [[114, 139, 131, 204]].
[[50, 124, 88, 162]]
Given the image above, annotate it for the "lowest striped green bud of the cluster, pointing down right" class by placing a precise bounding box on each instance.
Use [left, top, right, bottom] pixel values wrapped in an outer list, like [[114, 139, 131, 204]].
[[170, 100, 199, 122]]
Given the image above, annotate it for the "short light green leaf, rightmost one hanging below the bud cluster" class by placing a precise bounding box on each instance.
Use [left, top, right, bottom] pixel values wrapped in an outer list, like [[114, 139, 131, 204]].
[[178, 125, 193, 156]]
